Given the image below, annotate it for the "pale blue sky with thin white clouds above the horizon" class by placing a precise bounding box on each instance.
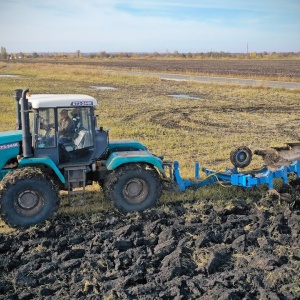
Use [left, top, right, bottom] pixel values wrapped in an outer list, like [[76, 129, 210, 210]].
[[0, 0, 300, 53]]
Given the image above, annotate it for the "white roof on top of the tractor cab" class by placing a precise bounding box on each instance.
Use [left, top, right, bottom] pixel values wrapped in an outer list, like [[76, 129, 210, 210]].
[[27, 94, 98, 108]]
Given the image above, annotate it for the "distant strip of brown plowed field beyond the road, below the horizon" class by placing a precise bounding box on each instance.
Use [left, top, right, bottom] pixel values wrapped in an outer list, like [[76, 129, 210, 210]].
[[7, 59, 300, 79]]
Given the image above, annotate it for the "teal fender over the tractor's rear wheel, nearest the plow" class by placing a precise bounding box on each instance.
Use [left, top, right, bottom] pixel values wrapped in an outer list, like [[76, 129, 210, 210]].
[[104, 150, 165, 176]]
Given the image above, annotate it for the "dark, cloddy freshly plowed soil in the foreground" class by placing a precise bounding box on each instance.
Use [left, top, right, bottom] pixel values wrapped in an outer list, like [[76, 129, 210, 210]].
[[0, 194, 300, 300]]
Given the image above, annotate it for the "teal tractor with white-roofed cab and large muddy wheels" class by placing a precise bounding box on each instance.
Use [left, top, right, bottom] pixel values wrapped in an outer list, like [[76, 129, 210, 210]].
[[0, 89, 167, 228]]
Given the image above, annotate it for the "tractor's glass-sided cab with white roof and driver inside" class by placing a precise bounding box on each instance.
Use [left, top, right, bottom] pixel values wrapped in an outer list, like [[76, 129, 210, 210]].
[[28, 94, 108, 167]]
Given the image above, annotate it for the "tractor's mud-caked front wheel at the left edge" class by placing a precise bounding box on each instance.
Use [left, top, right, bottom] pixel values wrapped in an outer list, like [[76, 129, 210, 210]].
[[0, 167, 60, 228]]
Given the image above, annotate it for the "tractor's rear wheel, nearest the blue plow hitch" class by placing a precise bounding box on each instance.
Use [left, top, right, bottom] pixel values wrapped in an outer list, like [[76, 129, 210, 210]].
[[104, 164, 162, 213]]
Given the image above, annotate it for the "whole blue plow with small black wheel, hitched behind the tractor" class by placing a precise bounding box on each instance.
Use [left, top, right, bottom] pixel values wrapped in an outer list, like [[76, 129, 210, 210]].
[[169, 143, 300, 191]]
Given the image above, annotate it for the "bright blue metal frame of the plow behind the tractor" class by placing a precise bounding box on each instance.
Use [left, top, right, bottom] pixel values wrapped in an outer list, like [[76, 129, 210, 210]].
[[173, 160, 300, 191]]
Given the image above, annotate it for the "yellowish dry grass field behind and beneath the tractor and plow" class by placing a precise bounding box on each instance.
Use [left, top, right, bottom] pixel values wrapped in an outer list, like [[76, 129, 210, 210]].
[[0, 63, 300, 232]]
